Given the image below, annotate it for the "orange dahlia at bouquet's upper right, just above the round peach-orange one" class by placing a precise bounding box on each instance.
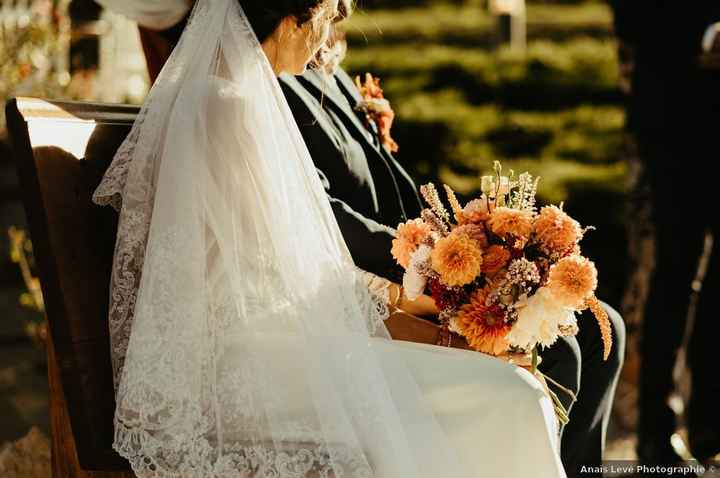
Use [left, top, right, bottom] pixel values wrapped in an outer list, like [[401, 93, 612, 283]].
[[534, 206, 582, 255]]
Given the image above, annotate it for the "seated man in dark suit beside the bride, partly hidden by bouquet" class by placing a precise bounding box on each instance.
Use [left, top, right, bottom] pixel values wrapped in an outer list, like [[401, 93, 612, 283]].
[[281, 1, 625, 477]]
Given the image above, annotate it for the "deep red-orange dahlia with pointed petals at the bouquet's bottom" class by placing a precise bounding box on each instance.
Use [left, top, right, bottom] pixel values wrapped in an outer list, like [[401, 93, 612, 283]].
[[453, 289, 512, 355]]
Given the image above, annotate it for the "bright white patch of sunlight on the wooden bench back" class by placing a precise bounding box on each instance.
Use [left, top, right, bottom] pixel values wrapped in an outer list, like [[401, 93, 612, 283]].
[[28, 118, 95, 159]]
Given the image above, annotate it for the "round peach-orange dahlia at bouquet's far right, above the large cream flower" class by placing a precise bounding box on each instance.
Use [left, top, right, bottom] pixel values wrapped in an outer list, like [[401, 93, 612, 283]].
[[547, 256, 597, 309]]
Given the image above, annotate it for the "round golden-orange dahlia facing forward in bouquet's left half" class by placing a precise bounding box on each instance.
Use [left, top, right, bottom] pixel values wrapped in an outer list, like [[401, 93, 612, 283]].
[[430, 232, 482, 287]]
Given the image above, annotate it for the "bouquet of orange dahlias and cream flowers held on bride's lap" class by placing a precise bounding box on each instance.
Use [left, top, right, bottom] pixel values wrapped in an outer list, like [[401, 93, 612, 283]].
[[391, 162, 612, 422]]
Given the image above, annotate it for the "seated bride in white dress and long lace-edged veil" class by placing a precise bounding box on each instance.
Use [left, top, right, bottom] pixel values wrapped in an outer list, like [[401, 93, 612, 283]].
[[94, 0, 565, 478]]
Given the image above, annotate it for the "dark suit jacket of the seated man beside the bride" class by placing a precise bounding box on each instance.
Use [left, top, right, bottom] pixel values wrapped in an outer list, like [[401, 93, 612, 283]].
[[280, 69, 420, 280]]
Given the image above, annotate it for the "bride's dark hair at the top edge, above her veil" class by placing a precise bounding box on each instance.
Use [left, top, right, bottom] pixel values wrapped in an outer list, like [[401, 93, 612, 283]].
[[238, 0, 342, 43]]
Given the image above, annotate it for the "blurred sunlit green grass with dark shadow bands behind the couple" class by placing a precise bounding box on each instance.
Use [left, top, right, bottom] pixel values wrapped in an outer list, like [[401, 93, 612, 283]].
[[344, 1, 625, 301]]
